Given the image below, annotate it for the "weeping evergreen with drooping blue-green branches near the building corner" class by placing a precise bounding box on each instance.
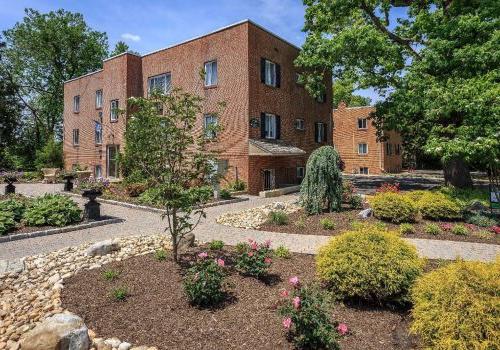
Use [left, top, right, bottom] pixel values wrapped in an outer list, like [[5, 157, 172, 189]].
[[300, 146, 342, 214]]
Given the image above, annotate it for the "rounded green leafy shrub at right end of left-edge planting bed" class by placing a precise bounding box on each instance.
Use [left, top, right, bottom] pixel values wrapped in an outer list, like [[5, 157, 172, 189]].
[[24, 194, 82, 226]]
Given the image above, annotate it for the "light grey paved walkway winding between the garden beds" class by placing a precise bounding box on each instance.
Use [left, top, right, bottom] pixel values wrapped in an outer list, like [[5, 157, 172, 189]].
[[0, 184, 500, 260]]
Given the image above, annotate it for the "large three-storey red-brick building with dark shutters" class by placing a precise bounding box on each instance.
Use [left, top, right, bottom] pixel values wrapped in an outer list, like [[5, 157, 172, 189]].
[[64, 20, 332, 194]]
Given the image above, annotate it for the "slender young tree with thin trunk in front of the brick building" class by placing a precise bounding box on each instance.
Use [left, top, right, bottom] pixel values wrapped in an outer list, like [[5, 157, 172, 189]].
[[122, 89, 224, 261]]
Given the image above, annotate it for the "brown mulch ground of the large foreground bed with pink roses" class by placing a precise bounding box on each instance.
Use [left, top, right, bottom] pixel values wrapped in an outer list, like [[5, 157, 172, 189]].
[[61, 248, 417, 350]]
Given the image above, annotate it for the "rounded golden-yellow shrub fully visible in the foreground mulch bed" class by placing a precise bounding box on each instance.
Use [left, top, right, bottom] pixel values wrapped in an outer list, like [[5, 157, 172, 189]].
[[316, 225, 423, 303]]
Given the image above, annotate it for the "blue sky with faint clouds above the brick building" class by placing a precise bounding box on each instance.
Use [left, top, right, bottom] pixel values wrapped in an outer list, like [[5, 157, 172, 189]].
[[0, 0, 390, 101]]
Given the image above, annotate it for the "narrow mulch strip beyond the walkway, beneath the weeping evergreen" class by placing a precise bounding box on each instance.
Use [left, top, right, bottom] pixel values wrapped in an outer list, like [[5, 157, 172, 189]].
[[259, 209, 500, 244]]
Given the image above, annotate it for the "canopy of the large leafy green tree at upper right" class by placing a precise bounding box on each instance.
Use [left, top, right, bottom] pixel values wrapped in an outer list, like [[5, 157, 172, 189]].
[[297, 0, 500, 187]]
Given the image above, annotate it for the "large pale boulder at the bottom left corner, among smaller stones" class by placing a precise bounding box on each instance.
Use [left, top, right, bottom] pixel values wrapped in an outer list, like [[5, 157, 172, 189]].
[[20, 313, 90, 350]]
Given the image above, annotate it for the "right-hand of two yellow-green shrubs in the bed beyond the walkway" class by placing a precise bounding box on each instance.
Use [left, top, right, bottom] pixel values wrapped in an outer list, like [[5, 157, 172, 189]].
[[417, 192, 462, 220]]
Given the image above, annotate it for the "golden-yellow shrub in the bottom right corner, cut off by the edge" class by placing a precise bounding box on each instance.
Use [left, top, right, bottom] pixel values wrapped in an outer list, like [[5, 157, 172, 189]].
[[411, 259, 500, 350]]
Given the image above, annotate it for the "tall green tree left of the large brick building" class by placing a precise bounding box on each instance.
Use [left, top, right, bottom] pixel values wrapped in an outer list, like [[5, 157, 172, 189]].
[[3, 9, 108, 149]]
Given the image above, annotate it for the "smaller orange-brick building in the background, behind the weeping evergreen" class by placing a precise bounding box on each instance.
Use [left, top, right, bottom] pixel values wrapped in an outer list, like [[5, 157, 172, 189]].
[[332, 102, 402, 175]]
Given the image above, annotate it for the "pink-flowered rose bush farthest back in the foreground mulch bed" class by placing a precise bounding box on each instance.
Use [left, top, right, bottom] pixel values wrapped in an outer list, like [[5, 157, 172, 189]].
[[236, 239, 272, 278]]
